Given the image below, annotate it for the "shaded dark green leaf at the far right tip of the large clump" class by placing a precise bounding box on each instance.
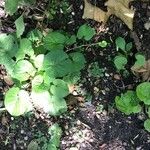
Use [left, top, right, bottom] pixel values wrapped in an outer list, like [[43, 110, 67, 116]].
[[70, 52, 86, 72]]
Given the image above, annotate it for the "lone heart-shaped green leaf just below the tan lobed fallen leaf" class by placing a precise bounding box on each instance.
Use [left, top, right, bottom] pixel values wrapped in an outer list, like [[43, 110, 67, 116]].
[[77, 24, 96, 41]]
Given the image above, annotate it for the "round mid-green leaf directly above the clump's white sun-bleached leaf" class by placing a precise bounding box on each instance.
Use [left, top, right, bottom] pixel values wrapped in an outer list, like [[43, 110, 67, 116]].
[[50, 79, 69, 98]]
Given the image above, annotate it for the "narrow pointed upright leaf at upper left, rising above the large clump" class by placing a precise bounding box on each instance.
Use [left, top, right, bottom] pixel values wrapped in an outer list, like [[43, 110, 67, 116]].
[[15, 15, 25, 38]]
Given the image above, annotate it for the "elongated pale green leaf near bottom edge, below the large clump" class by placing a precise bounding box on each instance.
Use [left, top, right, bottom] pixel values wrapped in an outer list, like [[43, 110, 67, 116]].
[[48, 123, 62, 148]]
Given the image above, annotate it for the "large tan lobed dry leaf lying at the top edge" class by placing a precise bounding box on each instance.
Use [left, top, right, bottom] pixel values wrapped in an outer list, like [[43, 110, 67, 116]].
[[83, 0, 148, 30]]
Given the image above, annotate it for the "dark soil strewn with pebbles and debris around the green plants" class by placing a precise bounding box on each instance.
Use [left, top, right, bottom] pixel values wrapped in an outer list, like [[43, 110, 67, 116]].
[[0, 0, 150, 150]]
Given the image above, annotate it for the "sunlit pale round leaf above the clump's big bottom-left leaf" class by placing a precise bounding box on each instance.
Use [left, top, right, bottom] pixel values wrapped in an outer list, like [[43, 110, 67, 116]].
[[13, 60, 36, 81]]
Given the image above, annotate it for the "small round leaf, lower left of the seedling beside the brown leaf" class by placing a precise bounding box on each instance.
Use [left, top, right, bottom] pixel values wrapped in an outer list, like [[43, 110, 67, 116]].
[[114, 55, 127, 71]]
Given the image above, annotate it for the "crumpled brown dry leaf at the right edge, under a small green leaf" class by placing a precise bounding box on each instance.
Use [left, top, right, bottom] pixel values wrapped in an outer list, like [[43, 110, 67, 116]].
[[131, 59, 150, 81]]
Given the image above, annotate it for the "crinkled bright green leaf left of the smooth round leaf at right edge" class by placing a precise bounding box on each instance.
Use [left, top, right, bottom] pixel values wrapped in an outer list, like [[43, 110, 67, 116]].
[[115, 91, 141, 115]]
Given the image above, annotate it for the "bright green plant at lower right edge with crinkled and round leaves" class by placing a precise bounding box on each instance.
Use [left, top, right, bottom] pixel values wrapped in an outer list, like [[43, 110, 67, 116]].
[[115, 82, 150, 132]]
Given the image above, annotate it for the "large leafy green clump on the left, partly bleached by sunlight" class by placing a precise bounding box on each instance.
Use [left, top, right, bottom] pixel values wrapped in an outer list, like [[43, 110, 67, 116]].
[[0, 23, 90, 116]]
